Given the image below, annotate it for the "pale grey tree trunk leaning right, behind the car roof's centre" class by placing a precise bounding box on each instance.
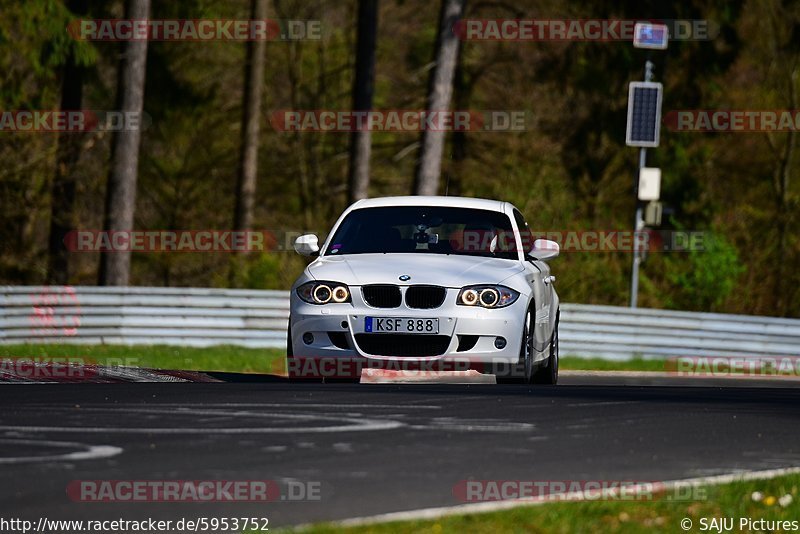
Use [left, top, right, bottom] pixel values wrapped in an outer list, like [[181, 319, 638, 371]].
[[414, 0, 466, 195]]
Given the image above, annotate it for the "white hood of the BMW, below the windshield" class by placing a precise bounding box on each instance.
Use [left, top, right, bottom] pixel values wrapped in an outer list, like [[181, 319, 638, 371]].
[[308, 253, 524, 287]]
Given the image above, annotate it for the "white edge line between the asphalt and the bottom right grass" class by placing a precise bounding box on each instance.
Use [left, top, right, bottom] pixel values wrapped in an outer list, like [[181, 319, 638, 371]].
[[324, 467, 800, 529]]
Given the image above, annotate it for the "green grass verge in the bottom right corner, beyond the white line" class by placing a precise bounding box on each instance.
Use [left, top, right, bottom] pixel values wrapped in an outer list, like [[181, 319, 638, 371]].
[[296, 475, 800, 534]]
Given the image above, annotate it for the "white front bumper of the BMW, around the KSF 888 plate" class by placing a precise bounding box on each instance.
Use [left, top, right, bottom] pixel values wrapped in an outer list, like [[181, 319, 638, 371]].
[[290, 286, 527, 364]]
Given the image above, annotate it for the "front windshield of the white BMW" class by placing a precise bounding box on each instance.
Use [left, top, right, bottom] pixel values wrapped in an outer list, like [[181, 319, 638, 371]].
[[325, 206, 517, 259]]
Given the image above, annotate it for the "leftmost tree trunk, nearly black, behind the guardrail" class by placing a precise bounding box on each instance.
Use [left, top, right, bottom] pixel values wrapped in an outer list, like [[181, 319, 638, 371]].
[[47, 0, 88, 285]]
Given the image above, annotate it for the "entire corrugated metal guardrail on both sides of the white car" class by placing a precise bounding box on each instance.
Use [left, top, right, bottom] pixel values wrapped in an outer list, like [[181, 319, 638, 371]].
[[0, 286, 800, 359]]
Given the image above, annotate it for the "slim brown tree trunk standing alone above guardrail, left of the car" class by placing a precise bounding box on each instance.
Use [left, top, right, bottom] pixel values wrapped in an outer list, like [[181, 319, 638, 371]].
[[230, 0, 267, 283]]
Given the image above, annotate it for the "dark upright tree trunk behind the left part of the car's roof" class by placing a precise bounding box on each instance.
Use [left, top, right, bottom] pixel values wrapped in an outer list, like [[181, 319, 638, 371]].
[[348, 0, 378, 203]]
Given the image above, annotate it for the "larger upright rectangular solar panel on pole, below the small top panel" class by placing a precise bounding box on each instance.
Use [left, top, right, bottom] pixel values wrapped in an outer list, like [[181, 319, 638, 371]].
[[625, 82, 664, 148]]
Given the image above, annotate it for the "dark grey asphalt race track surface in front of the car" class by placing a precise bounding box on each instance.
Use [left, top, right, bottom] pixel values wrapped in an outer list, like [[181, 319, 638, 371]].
[[0, 376, 800, 527]]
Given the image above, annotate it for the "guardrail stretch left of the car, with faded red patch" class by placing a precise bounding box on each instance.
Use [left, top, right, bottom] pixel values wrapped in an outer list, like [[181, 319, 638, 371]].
[[0, 286, 289, 347]]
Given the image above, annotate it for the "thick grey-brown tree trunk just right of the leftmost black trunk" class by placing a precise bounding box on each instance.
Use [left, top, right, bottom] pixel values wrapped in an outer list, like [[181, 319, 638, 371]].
[[100, 0, 150, 286]]
